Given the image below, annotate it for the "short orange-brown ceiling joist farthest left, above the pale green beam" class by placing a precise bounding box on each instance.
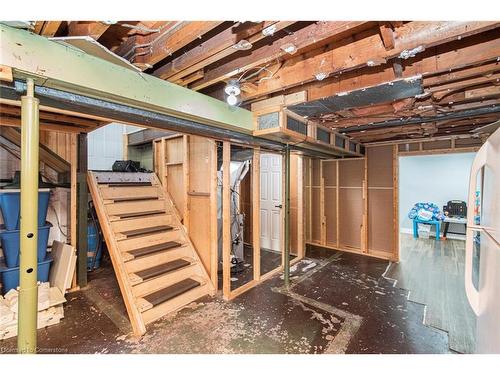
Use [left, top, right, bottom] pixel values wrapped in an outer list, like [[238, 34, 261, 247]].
[[134, 21, 222, 65]]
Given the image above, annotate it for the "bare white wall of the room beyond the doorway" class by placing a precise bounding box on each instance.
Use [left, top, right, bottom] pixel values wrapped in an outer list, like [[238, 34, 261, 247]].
[[399, 152, 476, 233]]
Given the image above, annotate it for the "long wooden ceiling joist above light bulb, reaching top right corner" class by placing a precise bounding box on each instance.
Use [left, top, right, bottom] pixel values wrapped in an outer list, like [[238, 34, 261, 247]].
[[240, 21, 500, 100]]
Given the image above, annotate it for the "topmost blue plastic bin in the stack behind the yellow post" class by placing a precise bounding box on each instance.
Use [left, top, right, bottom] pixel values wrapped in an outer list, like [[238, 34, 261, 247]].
[[0, 189, 50, 230]]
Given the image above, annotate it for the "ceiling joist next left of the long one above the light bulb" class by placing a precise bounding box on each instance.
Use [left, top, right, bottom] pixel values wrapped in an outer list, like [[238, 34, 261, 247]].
[[192, 21, 369, 90]]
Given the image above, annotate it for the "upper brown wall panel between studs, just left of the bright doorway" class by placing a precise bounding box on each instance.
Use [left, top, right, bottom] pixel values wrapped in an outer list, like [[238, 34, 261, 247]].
[[366, 145, 393, 187]]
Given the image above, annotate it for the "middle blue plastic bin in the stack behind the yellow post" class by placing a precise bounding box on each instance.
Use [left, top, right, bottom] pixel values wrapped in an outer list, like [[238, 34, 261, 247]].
[[0, 222, 52, 267]]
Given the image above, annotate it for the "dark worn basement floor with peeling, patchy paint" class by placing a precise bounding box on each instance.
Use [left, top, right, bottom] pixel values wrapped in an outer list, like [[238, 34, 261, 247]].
[[0, 248, 449, 354]]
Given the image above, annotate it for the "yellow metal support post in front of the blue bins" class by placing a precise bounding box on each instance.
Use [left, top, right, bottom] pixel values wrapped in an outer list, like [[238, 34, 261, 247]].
[[17, 79, 39, 354]]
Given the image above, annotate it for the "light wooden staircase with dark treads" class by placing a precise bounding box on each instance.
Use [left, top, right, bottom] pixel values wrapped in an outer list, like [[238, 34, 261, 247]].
[[88, 172, 215, 335]]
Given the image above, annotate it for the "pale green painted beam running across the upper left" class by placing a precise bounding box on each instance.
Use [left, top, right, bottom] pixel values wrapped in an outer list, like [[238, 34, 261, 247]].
[[0, 25, 253, 134]]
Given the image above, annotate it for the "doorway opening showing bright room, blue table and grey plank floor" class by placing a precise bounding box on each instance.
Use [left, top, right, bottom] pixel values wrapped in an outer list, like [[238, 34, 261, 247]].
[[386, 153, 475, 353]]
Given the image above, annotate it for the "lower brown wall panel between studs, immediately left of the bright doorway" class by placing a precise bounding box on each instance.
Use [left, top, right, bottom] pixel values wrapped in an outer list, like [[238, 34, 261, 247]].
[[368, 189, 394, 254]]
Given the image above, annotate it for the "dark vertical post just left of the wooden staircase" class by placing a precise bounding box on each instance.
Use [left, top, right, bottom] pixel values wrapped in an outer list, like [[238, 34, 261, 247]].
[[77, 133, 89, 288]]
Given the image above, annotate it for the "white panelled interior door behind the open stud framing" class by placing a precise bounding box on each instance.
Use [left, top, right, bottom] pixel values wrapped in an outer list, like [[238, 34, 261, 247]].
[[260, 154, 282, 251]]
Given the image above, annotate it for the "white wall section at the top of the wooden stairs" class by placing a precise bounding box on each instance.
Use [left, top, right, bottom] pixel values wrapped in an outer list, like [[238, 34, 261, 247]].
[[88, 123, 141, 170]]
